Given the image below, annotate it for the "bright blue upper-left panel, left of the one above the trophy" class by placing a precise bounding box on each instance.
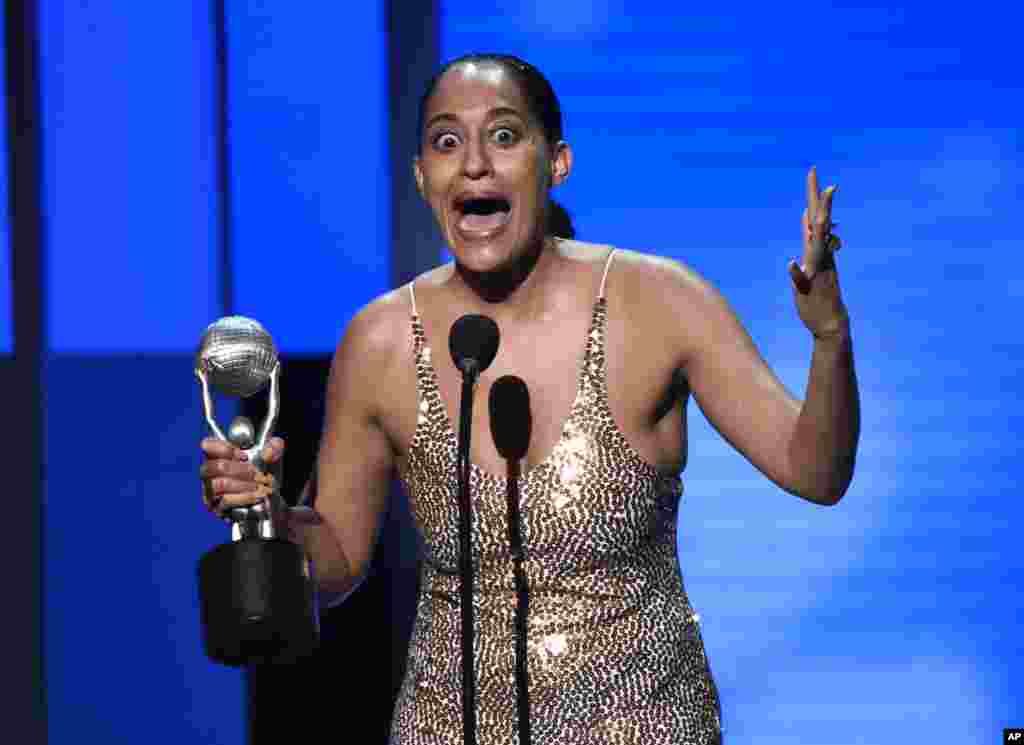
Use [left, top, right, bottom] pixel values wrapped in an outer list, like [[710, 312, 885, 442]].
[[40, 0, 219, 354]]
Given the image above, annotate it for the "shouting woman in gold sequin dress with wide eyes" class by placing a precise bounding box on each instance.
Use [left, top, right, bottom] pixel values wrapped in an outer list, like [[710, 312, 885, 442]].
[[202, 55, 858, 745]]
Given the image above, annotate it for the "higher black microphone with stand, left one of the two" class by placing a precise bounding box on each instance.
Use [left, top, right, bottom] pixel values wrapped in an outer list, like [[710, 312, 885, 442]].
[[449, 315, 499, 745]]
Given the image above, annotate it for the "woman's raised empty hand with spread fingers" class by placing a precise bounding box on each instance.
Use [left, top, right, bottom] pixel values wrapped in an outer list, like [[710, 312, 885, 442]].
[[790, 167, 849, 339]]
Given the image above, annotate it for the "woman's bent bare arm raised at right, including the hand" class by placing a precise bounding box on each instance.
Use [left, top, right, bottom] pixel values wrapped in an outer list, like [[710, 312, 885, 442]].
[[673, 171, 860, 505]]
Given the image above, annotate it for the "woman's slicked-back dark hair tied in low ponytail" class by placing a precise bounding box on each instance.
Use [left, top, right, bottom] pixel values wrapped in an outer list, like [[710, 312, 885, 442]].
[[416, 52, 575, 238]]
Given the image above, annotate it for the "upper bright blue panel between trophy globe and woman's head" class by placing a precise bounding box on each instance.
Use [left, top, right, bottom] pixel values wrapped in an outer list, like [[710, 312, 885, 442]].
[[229, 0, 391, 354]]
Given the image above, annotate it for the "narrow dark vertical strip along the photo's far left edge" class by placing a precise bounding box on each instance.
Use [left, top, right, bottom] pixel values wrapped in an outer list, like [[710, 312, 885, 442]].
[[0, 0, 47, 743]]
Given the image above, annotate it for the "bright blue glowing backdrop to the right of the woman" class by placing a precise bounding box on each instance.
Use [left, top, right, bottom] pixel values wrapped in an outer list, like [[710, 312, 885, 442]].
[[441, 0, 1024, 745]]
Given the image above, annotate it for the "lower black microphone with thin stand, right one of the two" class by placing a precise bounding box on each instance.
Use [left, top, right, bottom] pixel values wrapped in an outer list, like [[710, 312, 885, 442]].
[[488, 376, 532, 745]]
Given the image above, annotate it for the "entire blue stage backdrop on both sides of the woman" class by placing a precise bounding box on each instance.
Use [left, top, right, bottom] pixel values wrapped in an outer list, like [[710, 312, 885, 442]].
[[19, 0, 1024, 745]]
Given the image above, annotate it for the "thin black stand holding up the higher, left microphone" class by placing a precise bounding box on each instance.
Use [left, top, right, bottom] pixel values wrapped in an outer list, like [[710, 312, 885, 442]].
[[456, 358, 479, 745]]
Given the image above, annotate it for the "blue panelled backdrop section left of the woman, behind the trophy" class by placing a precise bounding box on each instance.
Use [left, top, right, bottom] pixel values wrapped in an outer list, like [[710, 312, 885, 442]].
[[40, 0, 390, 745]]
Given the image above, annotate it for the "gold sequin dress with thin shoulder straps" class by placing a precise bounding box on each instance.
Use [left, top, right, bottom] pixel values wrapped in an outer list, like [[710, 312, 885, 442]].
[[391, 253, 721, 745]]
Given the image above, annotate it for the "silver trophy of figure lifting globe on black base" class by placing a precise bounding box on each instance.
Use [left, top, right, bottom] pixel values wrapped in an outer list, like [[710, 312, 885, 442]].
[[196, 315, 319, 666]]
